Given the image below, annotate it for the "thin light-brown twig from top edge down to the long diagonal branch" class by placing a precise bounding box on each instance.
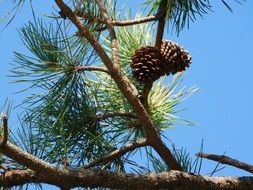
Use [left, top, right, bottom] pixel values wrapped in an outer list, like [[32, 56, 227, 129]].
[[96, 0, 119, 67]]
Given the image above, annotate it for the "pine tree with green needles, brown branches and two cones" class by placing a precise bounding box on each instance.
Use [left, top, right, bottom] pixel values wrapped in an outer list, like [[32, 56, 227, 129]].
[[0, 0, 253, 189]]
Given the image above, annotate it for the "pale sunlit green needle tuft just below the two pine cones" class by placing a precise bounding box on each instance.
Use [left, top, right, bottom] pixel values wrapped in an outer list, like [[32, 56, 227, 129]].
[[148, 73, 198, 130]]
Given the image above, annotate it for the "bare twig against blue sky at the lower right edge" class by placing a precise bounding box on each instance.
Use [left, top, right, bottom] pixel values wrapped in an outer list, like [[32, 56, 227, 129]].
[[196, 153, 253, 173]]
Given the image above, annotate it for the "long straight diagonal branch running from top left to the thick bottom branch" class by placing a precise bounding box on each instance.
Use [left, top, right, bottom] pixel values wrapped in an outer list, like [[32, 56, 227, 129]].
[[55, 0, 182, 170]]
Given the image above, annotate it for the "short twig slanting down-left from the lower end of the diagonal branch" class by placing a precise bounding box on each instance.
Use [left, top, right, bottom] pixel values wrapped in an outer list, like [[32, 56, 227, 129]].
[[84, 139, 148, 169]]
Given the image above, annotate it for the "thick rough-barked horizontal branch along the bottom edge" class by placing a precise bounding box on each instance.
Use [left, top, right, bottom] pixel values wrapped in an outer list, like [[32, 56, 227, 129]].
[[0, 170, 253, 190]]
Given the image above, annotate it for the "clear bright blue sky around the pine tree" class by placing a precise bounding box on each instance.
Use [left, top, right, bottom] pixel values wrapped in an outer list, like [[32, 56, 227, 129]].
[[0, 0, 253, 189]]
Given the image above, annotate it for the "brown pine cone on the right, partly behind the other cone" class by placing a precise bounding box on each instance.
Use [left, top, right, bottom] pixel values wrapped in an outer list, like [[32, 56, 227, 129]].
[[161, 40, 191, 75]]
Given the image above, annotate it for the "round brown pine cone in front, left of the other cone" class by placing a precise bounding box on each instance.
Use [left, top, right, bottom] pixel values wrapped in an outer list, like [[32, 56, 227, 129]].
[[131, 46, 163, 83]]
